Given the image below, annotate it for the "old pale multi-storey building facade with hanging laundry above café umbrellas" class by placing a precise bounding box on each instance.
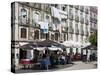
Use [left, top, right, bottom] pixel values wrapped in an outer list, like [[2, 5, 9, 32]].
[[11, 2, 97, 69]]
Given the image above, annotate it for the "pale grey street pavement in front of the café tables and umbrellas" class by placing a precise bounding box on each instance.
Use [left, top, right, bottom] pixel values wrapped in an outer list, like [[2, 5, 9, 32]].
[[14, 61, 97, 73]]
